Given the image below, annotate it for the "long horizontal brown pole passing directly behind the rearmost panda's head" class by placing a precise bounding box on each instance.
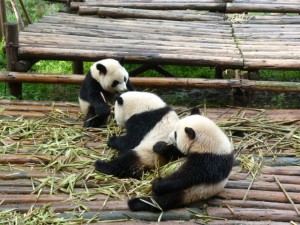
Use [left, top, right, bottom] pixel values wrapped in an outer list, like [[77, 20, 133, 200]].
[[0, 72, 300, 92]]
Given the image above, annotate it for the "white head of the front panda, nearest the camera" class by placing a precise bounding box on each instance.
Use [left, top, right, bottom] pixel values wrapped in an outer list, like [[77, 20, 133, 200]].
[[169, 115, 232, 154]]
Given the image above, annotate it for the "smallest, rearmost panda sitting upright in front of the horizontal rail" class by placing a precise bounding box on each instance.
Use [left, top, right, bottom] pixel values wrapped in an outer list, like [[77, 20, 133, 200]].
[[78, 59, 134, 127]]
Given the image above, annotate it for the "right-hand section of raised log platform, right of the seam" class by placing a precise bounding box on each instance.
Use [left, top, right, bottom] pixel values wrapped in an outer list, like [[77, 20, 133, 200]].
[[233, 16, 300, 70]]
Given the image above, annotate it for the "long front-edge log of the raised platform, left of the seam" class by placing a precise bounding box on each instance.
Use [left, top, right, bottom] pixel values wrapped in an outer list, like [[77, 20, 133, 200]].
[[19, 46, 243, 68]]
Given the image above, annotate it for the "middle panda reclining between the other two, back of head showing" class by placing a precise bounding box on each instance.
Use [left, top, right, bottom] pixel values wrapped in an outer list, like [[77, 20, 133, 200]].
[[95, 91, 182, 179]]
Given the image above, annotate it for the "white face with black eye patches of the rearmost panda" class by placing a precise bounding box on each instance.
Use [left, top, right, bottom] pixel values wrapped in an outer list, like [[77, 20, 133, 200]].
[[90, 59, 129, 93]]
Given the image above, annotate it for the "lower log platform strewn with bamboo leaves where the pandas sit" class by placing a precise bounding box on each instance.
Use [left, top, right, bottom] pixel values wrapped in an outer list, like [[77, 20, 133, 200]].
[[0, 100, 300, 224]]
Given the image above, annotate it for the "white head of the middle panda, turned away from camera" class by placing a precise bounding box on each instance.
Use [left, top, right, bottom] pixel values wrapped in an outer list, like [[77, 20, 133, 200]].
[[115, 91, 166, 128]]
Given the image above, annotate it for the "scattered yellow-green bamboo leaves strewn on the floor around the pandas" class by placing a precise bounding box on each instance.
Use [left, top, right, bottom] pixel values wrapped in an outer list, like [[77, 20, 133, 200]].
[[0, 109, 300, 224]]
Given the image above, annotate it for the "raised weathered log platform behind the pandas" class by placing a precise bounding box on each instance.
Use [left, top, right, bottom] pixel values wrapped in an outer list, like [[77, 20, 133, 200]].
[[14, 5, 300, 70]]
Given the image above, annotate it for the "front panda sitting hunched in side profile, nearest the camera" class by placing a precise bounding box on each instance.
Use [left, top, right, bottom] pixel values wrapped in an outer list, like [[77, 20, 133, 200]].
[[128, 110, 234, 211]]
